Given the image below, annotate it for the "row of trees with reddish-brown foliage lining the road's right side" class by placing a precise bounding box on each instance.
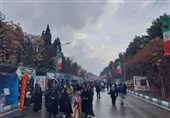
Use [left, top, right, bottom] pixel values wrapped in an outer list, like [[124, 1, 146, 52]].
[[100, 14, 170, 97]]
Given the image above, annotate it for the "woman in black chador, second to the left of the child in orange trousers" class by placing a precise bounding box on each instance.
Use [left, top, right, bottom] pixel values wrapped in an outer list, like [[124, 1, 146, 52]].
[[47, 88, 59, 118]]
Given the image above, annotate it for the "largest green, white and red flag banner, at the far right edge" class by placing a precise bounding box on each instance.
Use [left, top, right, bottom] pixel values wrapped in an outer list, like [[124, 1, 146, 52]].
[[162, 17, 170, 56]]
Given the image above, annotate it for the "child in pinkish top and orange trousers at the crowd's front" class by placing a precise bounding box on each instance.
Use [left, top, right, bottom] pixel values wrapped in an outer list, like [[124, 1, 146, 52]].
[[74, 91, 81, 118]]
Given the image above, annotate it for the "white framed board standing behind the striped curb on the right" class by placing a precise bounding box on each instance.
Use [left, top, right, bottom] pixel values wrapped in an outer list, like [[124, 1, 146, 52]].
[[133, 76, 150, 91]]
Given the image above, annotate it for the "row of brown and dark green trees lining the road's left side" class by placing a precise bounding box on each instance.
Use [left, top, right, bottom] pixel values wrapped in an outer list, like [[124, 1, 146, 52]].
[[0, 17, 84, 75]]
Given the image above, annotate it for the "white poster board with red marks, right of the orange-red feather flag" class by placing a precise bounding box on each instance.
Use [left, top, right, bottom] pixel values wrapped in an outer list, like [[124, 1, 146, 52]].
[[34, 76, 46, 91]]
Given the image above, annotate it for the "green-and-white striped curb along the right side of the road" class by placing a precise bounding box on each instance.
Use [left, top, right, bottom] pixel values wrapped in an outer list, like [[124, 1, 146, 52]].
[[127, 90, 170, 110]]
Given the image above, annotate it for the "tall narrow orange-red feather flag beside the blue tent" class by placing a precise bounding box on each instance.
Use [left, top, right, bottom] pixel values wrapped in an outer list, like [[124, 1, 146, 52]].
[[19, 71, 28, 111]]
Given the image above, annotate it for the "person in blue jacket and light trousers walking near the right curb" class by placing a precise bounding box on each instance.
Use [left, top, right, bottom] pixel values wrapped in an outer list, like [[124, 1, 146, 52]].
[[117, 83, 125, 105]]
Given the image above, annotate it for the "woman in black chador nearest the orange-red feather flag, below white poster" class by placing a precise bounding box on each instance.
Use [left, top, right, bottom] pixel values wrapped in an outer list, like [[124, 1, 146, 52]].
[[33, 84, 42, 112]]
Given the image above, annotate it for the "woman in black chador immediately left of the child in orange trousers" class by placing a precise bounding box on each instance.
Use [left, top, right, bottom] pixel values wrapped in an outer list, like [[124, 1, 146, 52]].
[[60, 88, 73, 117]]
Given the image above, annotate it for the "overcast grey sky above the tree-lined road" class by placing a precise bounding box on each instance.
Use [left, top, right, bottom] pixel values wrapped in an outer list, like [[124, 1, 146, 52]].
[[0, 0, 170, 75]]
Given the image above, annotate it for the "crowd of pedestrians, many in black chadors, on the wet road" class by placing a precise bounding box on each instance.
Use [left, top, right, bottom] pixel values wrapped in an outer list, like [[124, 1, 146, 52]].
[[26, 82, 126, 118]]
